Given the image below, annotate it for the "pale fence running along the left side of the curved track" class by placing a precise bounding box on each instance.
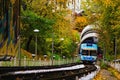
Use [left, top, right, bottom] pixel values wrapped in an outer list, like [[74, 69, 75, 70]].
[[0, 57, 80, 66]]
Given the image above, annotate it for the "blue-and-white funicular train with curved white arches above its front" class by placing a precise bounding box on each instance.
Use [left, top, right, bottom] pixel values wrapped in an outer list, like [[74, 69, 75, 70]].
[[79, 25, 98, 63]]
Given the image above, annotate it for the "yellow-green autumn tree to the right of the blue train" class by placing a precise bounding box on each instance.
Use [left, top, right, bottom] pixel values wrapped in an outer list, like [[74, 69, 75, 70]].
[[82, 0, 120, 57]]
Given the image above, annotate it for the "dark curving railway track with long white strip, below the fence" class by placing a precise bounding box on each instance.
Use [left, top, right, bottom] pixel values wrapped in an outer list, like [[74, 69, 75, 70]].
[[0, 63, 97, 80]]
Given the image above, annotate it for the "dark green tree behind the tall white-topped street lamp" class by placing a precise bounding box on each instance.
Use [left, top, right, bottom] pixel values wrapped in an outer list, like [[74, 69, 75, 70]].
[[21, 10, 53, 53]]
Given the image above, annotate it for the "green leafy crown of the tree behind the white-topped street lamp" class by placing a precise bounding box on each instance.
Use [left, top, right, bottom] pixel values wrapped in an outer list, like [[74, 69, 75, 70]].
[[21, 10, 54, 35]]
